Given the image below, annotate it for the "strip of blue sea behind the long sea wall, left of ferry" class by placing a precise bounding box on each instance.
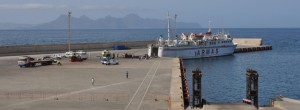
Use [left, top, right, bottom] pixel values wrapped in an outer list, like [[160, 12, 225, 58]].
[[0, 29, 164, 46]]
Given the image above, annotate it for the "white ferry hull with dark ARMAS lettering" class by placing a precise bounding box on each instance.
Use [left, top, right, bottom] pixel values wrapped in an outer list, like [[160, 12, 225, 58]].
[[158, 45, 236, 59]]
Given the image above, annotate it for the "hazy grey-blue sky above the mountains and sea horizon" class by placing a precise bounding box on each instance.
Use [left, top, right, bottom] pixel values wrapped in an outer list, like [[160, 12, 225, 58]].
[[0, 0, 300, 28]]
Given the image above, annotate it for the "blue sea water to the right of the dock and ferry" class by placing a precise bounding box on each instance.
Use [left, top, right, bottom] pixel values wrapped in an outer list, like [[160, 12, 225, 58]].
[[184, 29, 300, 105]]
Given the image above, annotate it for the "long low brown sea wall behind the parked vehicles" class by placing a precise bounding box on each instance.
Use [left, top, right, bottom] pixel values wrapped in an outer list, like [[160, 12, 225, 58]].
[[0, 41, 155, 55]]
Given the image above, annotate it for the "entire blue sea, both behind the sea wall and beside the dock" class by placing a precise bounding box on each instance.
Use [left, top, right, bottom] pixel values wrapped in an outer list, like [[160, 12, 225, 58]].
[[0, 28, 300, 105]]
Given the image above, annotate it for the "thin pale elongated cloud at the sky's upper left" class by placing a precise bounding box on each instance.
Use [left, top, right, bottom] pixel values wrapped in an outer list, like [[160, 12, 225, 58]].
[[0, 3, 65, 10]]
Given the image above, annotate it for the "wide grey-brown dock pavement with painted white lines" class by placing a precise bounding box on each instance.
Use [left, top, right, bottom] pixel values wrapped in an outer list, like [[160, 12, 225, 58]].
[[0, 49, 179, 110]]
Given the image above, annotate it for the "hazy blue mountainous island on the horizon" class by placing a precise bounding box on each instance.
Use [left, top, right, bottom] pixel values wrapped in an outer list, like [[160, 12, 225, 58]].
[[0, 14, 201, 29]]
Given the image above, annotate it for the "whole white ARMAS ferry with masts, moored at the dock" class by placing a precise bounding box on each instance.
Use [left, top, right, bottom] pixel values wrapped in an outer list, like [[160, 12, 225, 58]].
[[148, 15, 237, 59]]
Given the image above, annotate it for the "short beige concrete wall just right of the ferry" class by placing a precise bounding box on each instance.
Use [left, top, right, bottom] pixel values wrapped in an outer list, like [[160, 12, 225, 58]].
[[233, 38, 262, 46]]
